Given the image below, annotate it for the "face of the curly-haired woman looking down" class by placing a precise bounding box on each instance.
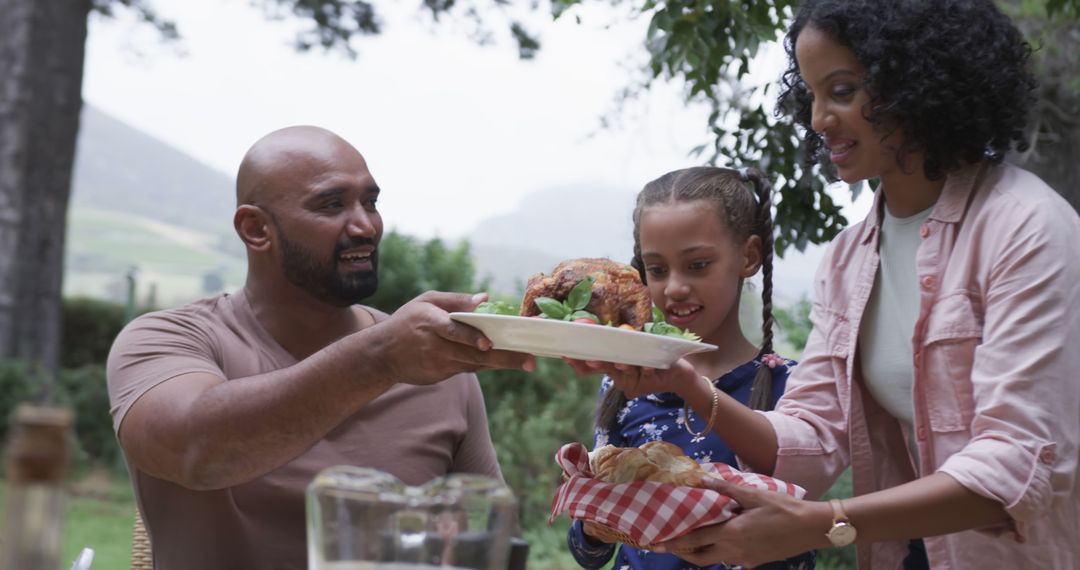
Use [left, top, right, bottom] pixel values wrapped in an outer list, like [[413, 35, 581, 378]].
[[795, 25, 900, 184]]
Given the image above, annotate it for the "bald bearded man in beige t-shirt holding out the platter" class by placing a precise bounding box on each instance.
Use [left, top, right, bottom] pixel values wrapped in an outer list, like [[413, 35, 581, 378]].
[[108, 126, 535, 570]]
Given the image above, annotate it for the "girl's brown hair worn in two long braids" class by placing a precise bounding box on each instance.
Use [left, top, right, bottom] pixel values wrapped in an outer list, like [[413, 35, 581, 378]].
[[596, 166, 773, 430]]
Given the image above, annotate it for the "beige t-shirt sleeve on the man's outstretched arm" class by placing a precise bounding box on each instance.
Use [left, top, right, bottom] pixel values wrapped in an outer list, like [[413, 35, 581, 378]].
[[106, 311, 225, 433]]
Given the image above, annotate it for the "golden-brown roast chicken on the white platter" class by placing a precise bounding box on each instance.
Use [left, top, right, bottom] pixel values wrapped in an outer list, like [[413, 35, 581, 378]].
[[521, 258, 652, 330]]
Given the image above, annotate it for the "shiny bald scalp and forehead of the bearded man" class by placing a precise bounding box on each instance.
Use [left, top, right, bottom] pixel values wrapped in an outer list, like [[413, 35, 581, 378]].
[[237, 125, 366, 206]]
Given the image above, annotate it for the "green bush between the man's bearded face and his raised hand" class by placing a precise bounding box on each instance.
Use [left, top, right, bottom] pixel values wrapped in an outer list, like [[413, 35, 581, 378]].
[[364, 232, 480, 313]]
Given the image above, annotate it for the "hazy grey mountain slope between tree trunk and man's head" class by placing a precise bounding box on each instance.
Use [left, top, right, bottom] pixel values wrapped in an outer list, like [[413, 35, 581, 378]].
[[71, 105, 235, 235]]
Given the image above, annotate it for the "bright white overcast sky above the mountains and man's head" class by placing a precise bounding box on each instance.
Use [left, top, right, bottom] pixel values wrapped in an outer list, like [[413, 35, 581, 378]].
[[83, 0, 865, 297]]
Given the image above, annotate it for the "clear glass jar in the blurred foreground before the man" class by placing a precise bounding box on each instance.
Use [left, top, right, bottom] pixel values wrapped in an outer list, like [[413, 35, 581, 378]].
[[307, 466, 517, 570]]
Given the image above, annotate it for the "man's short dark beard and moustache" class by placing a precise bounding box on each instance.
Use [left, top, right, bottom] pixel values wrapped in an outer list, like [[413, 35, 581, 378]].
[[278, 230, 379, 307]]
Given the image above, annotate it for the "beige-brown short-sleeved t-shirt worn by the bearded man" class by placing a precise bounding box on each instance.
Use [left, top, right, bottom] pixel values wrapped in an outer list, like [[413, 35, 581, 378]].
[[108, 290, 502, 570]]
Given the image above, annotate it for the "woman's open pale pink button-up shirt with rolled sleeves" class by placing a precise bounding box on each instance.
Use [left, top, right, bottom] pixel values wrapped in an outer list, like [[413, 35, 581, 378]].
[[766, 165, 1080, 570]]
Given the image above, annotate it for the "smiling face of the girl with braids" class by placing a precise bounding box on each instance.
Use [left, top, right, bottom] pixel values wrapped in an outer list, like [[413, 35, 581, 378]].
[[639, 200, 761, 343]]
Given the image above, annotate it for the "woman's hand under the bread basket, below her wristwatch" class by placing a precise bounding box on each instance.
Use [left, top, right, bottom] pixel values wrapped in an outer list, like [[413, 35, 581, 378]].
[[657, 477, 833, 568]]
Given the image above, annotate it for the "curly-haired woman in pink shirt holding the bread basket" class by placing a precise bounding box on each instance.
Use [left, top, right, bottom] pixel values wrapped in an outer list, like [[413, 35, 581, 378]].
[[570, 0, 1080, 570]]
